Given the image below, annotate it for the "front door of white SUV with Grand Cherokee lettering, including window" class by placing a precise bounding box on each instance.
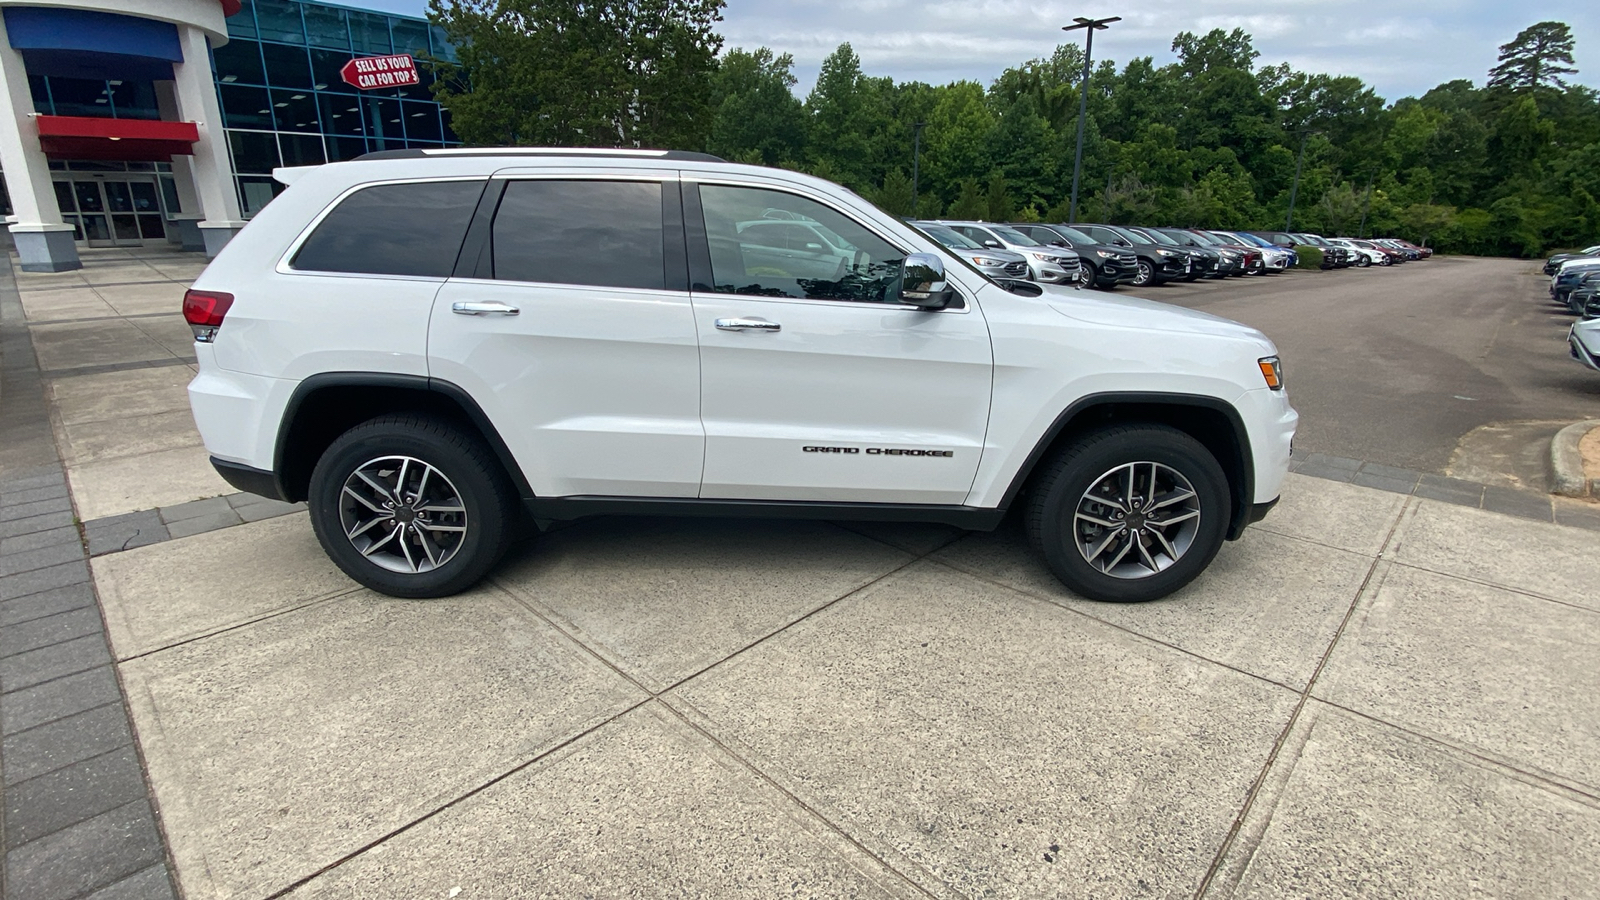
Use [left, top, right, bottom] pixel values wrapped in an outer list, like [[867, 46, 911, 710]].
[[685, 184, 994, 504]]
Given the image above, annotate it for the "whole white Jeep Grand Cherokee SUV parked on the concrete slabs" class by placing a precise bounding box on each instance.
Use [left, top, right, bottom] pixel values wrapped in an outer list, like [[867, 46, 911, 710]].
[[184, 149, 1298, 601]]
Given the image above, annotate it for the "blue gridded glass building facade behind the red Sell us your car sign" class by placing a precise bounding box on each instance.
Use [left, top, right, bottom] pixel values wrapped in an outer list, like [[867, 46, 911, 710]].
[[209, 0, 461, 216]]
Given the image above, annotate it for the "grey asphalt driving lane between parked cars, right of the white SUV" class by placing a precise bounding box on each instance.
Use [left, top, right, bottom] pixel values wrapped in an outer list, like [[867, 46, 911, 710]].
[[1145, 256, 1600, 492]]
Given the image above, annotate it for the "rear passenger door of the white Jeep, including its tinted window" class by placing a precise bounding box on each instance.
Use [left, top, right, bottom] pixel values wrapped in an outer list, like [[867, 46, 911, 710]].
[[429, 168, 706, 498]]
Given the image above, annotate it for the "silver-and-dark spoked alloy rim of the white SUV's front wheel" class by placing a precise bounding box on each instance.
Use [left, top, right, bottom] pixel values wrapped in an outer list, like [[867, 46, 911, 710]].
[[1072, 463, 1200, 580]]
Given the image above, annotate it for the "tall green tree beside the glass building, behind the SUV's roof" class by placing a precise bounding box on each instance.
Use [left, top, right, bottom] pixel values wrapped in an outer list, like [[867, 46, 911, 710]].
[[427, 0, 723, 147]]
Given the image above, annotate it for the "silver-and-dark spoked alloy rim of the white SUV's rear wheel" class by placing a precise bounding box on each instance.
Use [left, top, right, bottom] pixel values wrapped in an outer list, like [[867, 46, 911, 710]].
[[339, 456, 467, 573]]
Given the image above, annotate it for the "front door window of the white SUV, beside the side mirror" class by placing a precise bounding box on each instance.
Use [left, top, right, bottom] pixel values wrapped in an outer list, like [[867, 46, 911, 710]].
[[699, 184, 906, 303]]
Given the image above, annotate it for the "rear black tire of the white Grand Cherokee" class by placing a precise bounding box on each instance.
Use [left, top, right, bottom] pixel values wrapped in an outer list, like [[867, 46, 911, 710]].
[[307, 415, 518, 597]]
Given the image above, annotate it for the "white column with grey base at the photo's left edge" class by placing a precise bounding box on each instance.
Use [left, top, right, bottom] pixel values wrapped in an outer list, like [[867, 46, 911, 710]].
[[0, 18, 83, 272]]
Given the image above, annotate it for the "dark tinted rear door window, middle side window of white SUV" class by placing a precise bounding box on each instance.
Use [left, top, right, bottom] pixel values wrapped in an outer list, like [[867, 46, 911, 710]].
[[491, 181, 666, 290]]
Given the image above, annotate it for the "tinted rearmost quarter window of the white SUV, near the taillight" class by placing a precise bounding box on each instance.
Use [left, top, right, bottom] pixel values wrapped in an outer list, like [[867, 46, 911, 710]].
[[290, 181, 483, 279]]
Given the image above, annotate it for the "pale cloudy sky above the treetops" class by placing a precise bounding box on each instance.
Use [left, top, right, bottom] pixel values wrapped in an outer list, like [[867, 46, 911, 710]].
[[356, 0, 1600, 101]]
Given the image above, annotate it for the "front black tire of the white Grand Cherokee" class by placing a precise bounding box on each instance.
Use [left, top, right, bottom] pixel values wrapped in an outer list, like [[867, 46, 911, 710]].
[[1026, 424, 1232, 604]]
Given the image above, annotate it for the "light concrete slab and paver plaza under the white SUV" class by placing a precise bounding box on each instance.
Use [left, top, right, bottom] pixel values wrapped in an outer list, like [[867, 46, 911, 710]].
[[0, 246, 1600, 900]]
